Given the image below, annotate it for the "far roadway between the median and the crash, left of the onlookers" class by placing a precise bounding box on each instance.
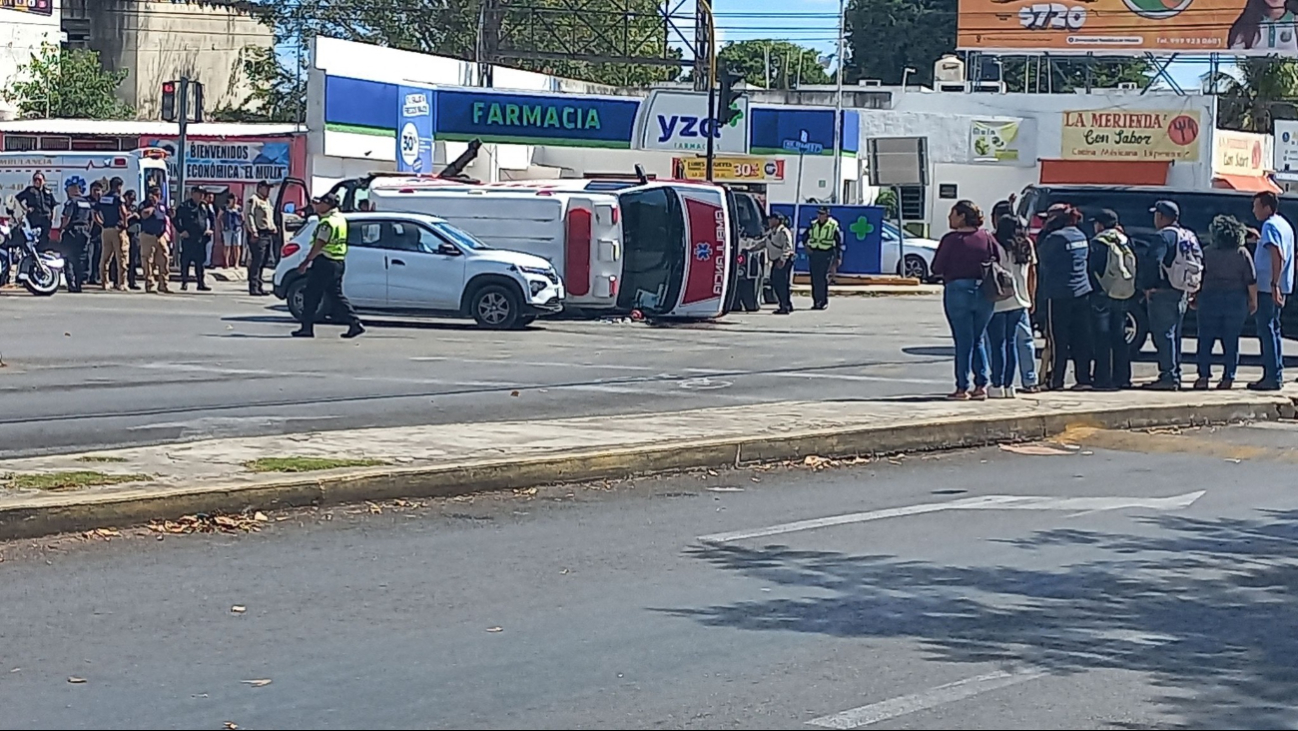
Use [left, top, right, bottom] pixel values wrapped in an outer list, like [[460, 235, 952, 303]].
[[0, 284, 951, 457]]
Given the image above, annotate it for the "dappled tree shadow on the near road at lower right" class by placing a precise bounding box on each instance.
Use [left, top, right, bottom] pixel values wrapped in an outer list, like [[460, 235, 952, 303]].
[[668, 512, 1298, 728]]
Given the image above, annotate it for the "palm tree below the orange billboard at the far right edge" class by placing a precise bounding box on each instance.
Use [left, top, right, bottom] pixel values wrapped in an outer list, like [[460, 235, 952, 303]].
[[1203, 58, 1298, 134]]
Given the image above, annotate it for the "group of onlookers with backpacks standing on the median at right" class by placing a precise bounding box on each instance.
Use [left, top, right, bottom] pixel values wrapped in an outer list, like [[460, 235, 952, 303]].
[[933, 186, 1294, 400]]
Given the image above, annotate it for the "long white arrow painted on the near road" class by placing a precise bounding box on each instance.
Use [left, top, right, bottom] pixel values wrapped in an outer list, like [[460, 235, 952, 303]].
[[698, 489, 1207, 543]]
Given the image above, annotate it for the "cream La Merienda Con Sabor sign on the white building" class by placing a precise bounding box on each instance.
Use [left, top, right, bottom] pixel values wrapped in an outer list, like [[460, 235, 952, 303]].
[[1060, 108, 1202, 162]]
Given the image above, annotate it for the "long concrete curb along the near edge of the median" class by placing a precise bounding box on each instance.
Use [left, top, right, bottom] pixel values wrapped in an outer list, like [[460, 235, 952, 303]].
[[0, 396, 1294, 540]]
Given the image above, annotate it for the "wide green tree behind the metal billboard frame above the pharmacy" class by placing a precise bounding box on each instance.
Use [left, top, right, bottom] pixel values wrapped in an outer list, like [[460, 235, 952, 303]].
[[257, 0, 681, 86]]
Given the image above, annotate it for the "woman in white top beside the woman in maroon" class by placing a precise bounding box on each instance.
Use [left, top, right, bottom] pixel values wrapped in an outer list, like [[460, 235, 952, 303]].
[[986, 216, 1037, 399]]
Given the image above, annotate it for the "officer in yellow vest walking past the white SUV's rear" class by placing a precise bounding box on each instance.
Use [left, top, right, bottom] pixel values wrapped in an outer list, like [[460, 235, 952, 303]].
[[293, 193, 365, 338]]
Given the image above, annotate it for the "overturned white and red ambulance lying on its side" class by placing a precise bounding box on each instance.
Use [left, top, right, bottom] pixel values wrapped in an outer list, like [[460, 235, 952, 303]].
[[369, 179, 739, 319]]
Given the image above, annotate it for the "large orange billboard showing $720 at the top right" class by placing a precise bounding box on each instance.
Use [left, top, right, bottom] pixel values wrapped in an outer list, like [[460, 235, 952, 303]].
[[957, 0, 1298, 56]]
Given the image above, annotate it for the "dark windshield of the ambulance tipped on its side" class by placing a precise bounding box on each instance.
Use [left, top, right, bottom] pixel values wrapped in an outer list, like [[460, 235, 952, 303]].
[[618, 188, 685, 312]]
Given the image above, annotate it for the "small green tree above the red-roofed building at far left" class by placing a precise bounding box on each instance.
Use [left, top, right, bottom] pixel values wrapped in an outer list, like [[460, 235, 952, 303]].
[[4, 44, 135, 119]]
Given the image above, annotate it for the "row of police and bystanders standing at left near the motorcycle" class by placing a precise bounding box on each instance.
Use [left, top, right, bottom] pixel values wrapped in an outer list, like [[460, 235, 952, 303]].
[[16, 173, 275, 295]]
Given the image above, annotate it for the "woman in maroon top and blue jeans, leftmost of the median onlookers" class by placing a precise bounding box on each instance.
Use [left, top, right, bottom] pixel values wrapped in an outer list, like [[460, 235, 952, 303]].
[[933, 200, 1001, 401]]
